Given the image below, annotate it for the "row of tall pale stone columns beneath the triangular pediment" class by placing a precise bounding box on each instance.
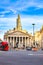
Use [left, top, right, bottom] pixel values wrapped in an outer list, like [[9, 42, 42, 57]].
[[6, 36, 30, 48]]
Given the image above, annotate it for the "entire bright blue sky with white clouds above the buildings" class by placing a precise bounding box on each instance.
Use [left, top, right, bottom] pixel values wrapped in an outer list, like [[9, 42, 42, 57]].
[[0, 0, 43, 38]]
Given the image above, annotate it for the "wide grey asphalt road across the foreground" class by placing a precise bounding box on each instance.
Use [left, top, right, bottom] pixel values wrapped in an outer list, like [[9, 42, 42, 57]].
[[0, 50, 43, 65]]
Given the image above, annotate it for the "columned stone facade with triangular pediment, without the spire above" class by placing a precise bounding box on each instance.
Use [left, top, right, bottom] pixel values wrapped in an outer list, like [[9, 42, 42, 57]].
[[4, 31, 31, 48]]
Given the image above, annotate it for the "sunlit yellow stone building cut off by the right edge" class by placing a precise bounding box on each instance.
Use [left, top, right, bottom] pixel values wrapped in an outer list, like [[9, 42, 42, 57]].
[[35, 26, 43, 48]]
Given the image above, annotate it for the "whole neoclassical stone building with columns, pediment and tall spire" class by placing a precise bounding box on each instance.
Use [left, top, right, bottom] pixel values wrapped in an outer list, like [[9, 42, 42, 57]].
[[4, 15, 32, 48]]
